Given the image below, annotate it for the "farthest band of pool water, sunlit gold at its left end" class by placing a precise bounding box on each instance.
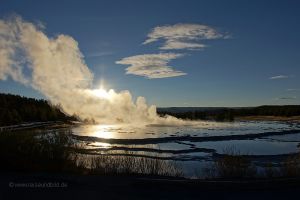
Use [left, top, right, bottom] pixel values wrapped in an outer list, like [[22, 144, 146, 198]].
[[72, 121, 296, 139]]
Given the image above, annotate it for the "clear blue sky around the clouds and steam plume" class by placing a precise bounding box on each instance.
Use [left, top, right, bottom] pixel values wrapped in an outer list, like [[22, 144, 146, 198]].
[[0, 0, 300, 106]]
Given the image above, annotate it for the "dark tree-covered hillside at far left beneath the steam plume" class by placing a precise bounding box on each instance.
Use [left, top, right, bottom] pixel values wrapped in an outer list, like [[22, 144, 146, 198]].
[[0, 93, 72, 126]]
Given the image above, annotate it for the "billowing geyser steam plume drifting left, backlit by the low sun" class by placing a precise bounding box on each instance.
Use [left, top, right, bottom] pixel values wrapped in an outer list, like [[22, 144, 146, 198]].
[[0, 16, 183, 124]]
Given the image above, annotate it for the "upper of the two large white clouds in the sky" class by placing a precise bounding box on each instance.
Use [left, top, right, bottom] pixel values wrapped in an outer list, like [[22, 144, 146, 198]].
[[143, 24, 228, 50]]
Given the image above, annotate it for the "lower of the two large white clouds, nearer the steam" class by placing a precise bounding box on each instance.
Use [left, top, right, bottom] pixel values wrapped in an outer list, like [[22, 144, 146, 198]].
[[116, 53, 186, 79]]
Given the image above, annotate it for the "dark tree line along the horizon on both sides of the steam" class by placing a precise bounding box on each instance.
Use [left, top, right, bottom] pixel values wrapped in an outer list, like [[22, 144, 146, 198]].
[[0, 93, 300, 126]]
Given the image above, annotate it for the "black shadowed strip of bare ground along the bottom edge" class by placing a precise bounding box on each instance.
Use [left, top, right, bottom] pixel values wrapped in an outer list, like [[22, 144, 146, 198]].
[[0, 173, 300, 200]]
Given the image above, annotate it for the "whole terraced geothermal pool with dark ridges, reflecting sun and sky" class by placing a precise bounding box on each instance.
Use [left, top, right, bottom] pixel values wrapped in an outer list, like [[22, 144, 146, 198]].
[[67, 121, 300, 176]]
